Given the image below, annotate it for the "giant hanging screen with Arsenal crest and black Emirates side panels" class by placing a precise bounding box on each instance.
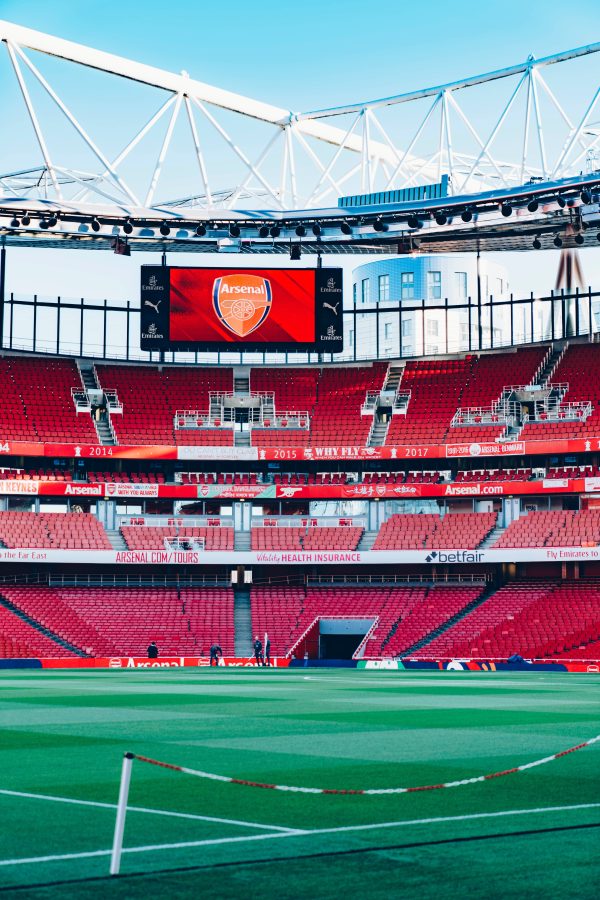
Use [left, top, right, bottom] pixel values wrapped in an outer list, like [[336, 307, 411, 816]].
[[140, 266, 344, 353]]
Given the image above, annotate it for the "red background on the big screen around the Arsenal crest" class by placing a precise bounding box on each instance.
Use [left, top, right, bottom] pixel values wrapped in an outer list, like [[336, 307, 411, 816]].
[[169, 268, 315, 344]]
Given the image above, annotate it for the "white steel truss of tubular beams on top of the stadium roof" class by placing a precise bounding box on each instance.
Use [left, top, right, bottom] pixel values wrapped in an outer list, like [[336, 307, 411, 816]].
[[0, 21, 600, 212]]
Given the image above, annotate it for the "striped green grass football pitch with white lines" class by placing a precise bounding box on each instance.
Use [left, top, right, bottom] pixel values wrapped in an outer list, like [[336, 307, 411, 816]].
[[0, 669, 600, 900]]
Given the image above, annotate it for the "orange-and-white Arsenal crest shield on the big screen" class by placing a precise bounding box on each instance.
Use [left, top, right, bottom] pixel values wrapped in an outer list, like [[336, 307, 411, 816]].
[[213, 273, 273, 338]]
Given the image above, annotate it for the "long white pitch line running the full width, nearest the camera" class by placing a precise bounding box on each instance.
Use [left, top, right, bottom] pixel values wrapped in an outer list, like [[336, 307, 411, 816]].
[[0, 803, 600, 866]]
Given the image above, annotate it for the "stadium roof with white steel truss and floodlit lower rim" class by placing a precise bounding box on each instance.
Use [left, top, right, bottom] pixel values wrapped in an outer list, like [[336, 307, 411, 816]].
[[0, 21, 600, 254]]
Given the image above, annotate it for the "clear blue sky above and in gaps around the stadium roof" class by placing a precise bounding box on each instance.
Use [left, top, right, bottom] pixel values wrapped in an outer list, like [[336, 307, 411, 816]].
[[0, 0, 600, 297]]
